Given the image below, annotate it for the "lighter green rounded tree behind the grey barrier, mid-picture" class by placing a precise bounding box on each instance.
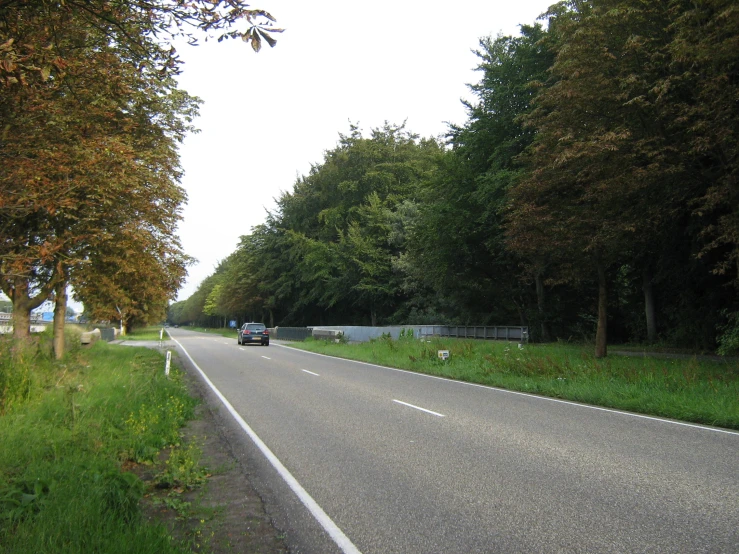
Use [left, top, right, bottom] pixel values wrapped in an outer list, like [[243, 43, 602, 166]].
[[278, 123, 439, 323]]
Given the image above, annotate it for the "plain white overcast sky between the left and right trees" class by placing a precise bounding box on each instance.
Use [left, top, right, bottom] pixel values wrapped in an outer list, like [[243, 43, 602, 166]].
[[172, 0, 554, 300]]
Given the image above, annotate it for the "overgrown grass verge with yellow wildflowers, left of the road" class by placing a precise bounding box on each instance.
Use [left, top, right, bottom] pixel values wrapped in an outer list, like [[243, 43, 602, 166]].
[[0, 334, 202, 554]]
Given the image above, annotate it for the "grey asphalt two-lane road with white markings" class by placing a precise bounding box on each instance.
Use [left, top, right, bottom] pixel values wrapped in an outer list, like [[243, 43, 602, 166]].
[[165, 329, 739, 554]]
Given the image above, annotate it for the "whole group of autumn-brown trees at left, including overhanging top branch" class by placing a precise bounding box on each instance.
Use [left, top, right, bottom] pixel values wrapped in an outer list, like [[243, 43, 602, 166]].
[[0, 0, 280, 356]]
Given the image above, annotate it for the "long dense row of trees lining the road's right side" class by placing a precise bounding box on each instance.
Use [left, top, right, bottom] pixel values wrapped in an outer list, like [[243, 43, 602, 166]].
[[170, 0, 739, 356]]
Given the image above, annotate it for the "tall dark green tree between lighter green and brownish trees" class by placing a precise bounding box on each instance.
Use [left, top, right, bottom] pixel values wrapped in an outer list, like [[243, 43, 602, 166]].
[[409, 25, 553, 330]]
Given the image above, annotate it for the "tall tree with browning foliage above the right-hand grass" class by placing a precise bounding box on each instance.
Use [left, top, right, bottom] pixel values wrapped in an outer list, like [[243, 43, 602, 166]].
[[508, 0, 732, 356]]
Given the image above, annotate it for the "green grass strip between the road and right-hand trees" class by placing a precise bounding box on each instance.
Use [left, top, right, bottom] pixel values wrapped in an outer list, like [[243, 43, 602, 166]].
[[291, 337, 739, 429]]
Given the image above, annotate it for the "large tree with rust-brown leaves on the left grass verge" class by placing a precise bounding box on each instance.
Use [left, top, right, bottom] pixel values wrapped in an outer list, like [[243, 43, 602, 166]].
[[0, 1, 202, 355]]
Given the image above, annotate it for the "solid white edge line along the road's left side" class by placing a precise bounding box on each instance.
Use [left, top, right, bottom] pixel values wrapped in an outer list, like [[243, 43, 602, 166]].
[[170, 335, 361, 554]]
